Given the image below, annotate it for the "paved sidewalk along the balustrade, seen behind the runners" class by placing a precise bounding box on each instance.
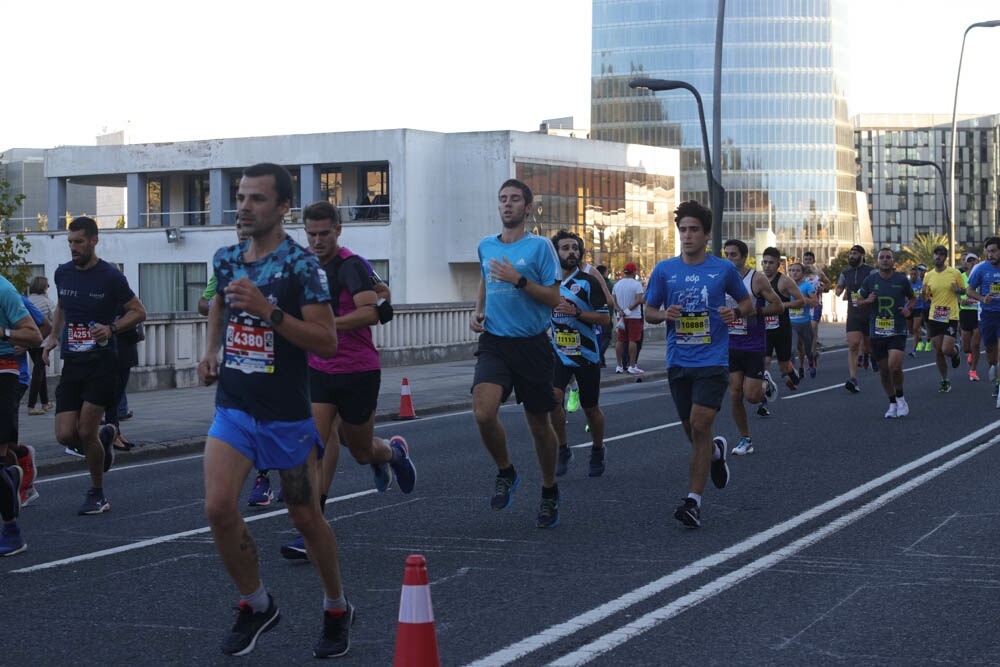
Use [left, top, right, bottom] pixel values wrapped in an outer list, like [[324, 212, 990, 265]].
[[25, 322, 846, 475]]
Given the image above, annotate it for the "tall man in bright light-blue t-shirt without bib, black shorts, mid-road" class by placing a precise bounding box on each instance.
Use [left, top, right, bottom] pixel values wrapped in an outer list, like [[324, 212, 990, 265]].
[[469, 178, 562, 528]]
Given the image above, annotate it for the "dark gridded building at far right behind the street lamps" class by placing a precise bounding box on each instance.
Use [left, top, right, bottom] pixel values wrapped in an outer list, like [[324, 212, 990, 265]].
[[854, 114, 1000, 251]]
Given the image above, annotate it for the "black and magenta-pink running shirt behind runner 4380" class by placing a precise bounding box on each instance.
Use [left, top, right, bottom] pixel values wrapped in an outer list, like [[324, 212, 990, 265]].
[[309, 248, 381, 375]]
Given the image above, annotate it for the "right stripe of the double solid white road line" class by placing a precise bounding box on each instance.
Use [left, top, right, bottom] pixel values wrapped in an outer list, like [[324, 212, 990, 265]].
[[549, 437, 1000, 667]]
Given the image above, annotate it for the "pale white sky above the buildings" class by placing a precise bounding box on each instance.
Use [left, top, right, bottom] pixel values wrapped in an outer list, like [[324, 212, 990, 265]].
[[0, 0, 1000, 150]]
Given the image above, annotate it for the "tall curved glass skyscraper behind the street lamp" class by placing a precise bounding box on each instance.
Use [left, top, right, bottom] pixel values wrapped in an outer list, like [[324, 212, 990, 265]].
[[591, 0, 859, 262]]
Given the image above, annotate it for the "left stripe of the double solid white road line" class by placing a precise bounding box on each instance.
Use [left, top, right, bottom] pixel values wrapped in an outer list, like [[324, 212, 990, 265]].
[[470, 424, 1000, 667]]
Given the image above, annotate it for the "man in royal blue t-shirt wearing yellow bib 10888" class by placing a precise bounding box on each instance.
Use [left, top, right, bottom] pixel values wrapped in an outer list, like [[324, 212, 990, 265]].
[[646, 201, 755, 528]]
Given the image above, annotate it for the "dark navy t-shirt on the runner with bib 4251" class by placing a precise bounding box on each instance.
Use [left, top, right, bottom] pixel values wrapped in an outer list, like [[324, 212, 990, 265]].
[[54, 259, 135, 361]]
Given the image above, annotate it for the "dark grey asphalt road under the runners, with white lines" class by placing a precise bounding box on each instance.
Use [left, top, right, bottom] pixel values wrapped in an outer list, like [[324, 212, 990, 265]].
[[0, 352, 1000, 666]]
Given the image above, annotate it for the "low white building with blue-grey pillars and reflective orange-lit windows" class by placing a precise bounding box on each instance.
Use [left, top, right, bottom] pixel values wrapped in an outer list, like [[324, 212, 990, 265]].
[[28, 129, 680, 313]]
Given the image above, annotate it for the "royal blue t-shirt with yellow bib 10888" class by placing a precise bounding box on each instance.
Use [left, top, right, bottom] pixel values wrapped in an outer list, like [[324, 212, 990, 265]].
[[646, 255, 748, 368]]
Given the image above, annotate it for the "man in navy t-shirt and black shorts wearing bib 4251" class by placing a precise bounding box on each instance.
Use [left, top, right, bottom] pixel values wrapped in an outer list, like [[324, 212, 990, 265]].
[[42, 217, 146, 516]]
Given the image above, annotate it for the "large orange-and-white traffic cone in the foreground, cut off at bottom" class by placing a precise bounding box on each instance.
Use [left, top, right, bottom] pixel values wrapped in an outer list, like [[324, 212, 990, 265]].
[[392, 552, 441, 667]]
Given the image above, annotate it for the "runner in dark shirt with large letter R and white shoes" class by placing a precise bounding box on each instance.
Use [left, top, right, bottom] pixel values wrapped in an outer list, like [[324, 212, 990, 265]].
[[858, 248, 916, 419]]
